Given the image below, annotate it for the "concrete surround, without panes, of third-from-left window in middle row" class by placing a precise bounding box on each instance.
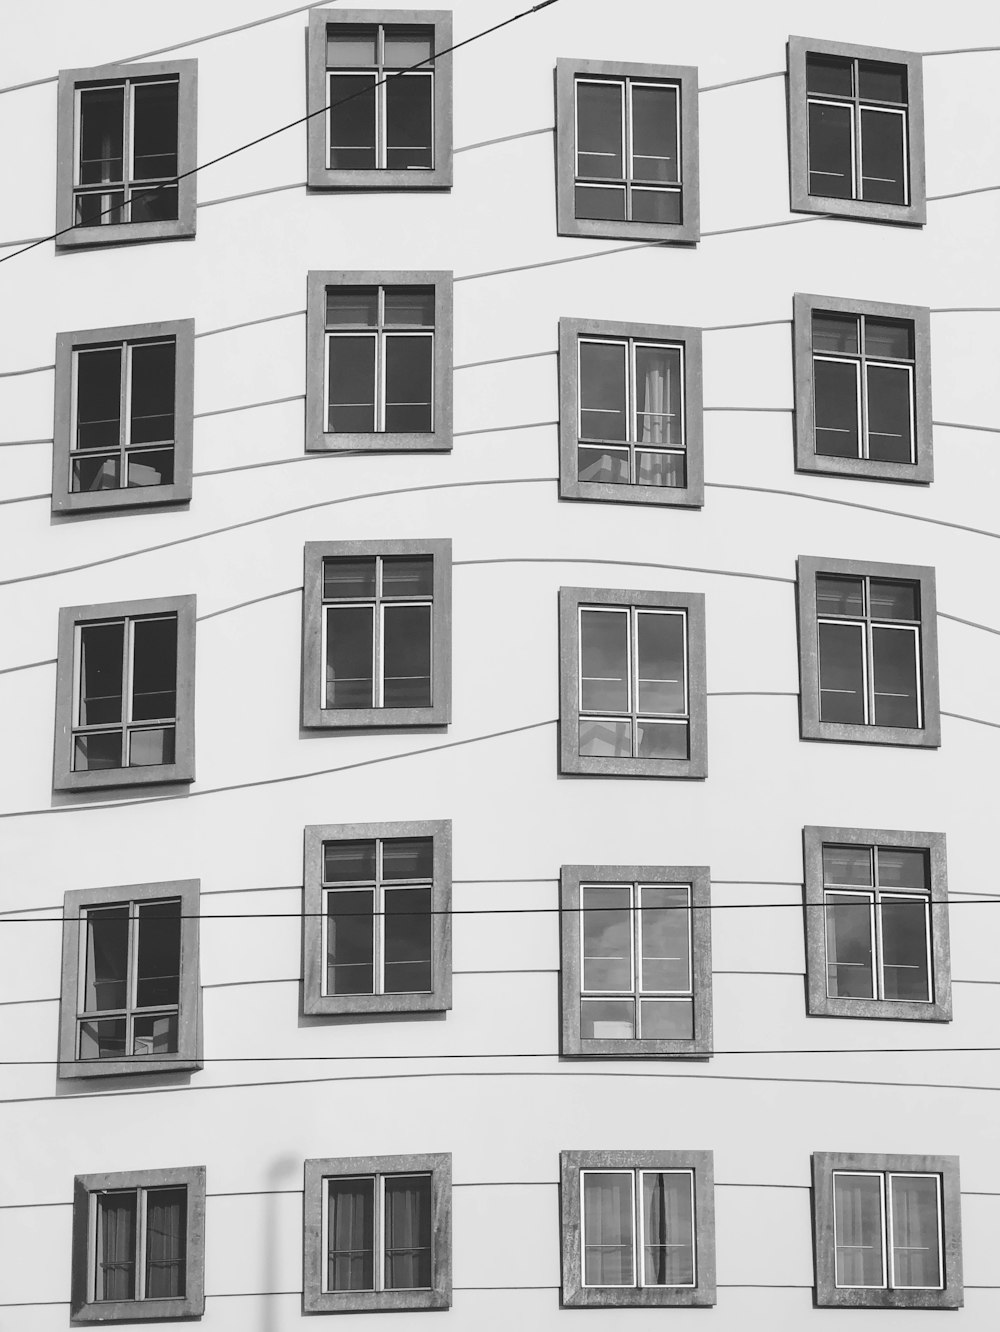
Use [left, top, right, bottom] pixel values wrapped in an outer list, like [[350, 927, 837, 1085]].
[[559, 587, 708, 778]]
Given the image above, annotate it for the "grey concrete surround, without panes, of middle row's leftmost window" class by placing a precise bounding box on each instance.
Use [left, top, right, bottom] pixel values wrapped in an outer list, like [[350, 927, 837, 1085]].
[[52, 593, 197, 791]]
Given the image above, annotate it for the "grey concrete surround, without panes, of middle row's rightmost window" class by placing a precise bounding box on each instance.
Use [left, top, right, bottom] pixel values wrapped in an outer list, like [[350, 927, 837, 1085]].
[[796, 555, 941, 749]]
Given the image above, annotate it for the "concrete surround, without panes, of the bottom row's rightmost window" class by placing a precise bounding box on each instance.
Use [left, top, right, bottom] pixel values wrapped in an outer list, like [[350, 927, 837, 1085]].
[[812, 1152, 964, 1309]]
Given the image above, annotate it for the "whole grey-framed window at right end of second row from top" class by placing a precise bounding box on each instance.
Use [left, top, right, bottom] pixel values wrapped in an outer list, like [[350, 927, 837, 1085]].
[[794, 294, 933, 482]]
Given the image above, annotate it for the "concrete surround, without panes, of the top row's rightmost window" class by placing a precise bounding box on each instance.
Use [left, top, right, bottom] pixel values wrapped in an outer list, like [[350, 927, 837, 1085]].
[[787, 37, 927, 226]]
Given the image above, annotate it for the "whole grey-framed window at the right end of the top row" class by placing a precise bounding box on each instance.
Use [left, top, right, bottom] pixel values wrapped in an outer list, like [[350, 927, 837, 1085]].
[[788, 37, 927, 226]]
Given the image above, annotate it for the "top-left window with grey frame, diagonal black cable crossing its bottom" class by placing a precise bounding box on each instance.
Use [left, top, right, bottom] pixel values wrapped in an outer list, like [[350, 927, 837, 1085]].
[[56, 60, 198, 249]]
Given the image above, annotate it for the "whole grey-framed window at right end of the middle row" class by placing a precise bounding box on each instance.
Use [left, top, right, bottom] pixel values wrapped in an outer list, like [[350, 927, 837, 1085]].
[[799, 555, 941, 747]]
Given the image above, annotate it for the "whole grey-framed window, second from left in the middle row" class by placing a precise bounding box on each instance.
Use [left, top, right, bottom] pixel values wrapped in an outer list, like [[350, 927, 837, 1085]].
[[302, 539, 451, 729]]
